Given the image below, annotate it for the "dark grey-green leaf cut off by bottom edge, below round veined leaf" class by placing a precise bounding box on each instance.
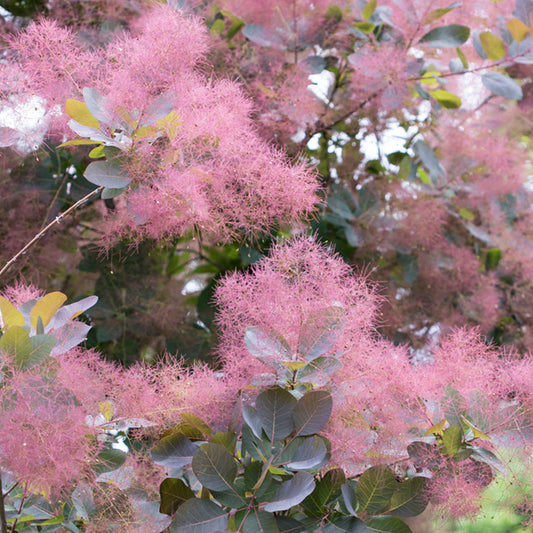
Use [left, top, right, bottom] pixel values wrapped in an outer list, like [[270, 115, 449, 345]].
[[169, 498, 228, 533]]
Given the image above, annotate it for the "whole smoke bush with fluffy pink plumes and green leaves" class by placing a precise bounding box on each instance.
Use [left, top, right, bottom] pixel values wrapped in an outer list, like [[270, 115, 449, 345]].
[[0, 0, 533, 533]]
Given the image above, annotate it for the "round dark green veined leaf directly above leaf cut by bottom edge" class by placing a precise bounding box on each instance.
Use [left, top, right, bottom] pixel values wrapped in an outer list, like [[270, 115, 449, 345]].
[[192, 443, 237, 491]]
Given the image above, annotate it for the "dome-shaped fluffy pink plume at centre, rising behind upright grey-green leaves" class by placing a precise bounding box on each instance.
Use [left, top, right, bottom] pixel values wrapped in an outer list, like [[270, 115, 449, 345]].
[[216, 237, 377, 384]]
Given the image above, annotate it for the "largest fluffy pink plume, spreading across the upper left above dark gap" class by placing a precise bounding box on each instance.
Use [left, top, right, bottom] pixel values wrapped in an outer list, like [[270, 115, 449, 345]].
[[6, 6, 318, 243]]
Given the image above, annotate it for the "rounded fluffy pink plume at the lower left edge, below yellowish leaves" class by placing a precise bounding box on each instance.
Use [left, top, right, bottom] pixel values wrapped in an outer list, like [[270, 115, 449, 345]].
[[0, 372, 97, 494]]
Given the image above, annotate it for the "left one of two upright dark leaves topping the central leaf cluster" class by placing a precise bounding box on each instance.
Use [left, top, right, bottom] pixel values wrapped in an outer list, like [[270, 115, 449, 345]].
[[255, 387, 296, 442]]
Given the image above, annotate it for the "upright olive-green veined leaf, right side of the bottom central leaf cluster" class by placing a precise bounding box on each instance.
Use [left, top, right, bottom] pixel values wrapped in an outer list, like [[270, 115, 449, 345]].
[[355, 465, 398, 514]]
